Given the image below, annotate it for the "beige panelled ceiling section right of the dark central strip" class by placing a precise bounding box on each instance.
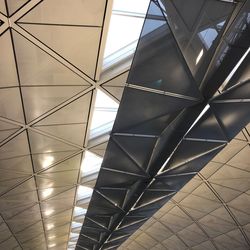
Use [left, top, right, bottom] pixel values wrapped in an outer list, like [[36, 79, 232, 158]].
[[118, 126, 250, 250]]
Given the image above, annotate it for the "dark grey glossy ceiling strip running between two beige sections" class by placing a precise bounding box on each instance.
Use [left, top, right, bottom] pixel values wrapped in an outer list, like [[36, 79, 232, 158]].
[[76, 0, 250, 249]]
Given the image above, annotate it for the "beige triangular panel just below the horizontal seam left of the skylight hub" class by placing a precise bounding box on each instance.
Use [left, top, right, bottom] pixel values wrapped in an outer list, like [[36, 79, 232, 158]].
[[22, 86, 87, 122]]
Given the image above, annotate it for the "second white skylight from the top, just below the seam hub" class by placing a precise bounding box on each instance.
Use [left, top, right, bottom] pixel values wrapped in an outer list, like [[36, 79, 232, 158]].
[[90, 90, 119, 139]]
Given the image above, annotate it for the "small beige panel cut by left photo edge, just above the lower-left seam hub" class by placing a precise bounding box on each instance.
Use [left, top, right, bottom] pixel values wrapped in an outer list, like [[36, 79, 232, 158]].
[[0, 88, 24, 123]]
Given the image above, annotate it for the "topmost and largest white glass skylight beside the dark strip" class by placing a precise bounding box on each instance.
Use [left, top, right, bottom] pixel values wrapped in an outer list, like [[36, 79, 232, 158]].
[[103, 0, 149, 70]]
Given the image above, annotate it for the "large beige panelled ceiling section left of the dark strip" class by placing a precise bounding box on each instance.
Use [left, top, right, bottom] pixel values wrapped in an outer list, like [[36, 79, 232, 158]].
[[0, 0, 129, 250]]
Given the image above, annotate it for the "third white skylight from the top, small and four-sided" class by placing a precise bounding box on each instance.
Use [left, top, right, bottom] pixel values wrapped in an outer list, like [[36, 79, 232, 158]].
[[81, 151, 102, 177]]
